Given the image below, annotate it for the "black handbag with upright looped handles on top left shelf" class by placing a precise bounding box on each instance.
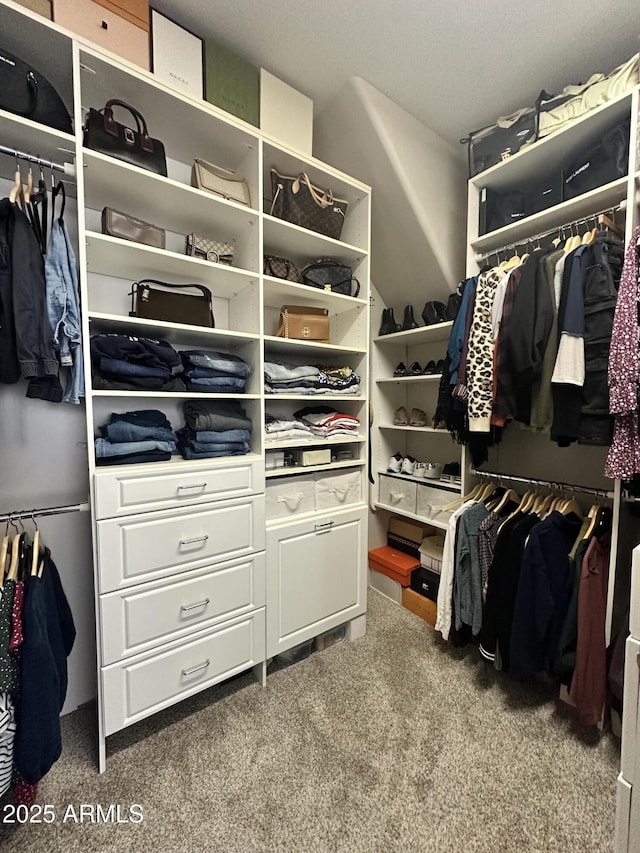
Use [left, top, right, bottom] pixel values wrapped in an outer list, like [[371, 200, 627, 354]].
[[84, 100, 167, 178]]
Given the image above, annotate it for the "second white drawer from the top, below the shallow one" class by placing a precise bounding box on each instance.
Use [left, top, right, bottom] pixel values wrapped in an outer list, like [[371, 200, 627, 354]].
[[97, 495, 265, 593]]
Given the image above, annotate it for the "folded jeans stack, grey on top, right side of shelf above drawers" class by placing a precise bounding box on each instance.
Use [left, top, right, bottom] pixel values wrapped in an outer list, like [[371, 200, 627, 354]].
[[177, 400, 253, 459]]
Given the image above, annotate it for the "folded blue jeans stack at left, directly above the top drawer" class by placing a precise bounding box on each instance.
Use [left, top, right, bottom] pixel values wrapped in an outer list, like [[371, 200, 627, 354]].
[[95, 409, 177, 465]]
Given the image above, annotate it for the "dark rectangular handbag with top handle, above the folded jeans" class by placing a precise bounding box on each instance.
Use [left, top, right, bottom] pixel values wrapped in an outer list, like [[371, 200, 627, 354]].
[[129, 278, 215, 329]]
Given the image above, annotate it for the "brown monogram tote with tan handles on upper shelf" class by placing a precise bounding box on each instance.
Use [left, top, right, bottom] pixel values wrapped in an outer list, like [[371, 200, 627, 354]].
[[270, 169, 348, 240]]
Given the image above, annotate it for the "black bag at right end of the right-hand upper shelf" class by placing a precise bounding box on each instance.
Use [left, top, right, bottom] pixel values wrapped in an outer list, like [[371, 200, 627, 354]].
[[563, 118, 630, 201]]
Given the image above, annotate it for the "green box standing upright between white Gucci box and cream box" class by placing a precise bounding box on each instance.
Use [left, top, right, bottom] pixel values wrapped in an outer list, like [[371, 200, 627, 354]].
[[204, 39, 260, 127]]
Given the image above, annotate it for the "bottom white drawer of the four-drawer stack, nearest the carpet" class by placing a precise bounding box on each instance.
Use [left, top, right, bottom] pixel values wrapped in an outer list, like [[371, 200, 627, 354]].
[[101, 608, 265, 735]]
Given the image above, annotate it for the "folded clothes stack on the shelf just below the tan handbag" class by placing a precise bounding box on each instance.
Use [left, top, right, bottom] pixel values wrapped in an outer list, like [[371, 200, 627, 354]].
[[264, 361, 360, 397]]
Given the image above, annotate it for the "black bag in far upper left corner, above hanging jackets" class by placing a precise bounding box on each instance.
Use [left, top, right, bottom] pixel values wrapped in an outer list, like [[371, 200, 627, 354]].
[[0, 48, 73, 133]]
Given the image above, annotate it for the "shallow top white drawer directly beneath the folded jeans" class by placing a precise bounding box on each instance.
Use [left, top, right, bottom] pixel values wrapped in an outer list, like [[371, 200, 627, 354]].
[[95, 458, 264, 518]]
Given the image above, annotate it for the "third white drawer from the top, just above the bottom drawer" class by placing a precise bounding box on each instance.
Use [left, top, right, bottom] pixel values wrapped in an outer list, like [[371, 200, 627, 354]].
[[100, 551, 265, 666]]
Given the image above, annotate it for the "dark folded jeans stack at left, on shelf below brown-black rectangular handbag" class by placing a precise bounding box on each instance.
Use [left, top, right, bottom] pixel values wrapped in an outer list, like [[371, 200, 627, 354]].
[[91, 334, 186, 391]]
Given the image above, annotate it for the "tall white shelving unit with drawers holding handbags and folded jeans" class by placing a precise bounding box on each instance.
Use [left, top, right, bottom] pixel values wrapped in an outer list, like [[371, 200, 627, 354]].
[[0, 0, 371, 771]]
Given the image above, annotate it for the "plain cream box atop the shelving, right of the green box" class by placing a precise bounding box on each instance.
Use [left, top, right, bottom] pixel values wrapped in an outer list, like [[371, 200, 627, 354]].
[[260, 68, 313, 155]]
